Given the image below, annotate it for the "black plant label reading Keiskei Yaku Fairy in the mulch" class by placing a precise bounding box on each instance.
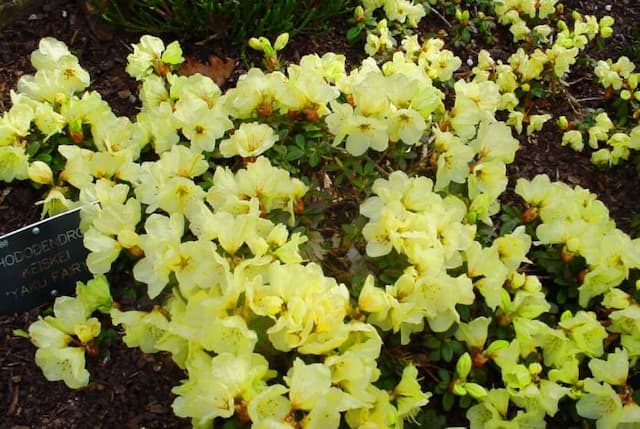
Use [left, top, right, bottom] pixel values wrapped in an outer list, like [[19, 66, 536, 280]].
[[0, 208, 92, 314]]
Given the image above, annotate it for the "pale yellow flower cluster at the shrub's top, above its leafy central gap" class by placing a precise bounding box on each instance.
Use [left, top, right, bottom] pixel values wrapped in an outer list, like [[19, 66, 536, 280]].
[[326, 37, 461, 156]]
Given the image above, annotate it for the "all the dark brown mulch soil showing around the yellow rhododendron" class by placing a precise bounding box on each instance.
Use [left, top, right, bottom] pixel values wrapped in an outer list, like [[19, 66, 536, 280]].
[[0, 0, 640, 429]]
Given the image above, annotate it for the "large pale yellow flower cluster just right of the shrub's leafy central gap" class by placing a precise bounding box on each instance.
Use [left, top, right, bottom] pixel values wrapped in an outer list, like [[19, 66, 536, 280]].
[[358, 171, 475, 338]]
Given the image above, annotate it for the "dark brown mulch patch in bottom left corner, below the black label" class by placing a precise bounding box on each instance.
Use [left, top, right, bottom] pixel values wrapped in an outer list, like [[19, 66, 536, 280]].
[[0, 310, 191, 429]]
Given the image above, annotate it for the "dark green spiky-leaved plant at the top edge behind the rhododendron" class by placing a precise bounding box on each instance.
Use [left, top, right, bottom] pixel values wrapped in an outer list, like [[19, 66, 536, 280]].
[[88, 0, 356, 44]]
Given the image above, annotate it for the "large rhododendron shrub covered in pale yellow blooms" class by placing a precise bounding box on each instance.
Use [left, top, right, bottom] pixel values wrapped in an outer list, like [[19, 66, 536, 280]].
[[0, 1, 640, 428]]
